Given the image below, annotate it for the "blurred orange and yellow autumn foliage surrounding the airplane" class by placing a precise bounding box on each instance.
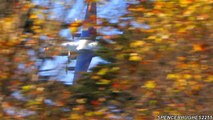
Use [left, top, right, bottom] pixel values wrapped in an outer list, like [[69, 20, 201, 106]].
[[0, 0, 213, 120]]
